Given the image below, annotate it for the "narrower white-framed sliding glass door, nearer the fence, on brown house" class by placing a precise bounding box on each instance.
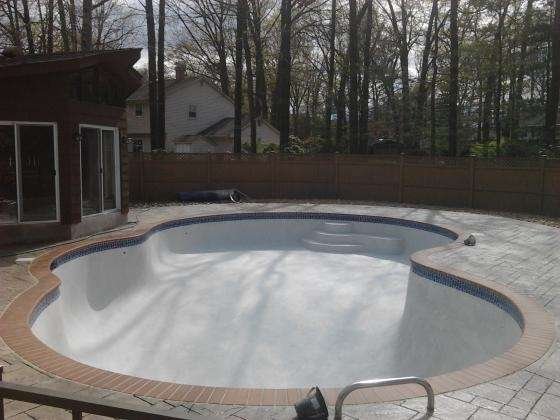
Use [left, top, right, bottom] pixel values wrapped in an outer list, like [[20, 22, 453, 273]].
[[81, 126, 120, 216]]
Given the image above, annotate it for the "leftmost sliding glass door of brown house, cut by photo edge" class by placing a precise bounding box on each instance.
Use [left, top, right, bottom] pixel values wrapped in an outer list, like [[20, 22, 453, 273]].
[[0, 122, 59, 223]]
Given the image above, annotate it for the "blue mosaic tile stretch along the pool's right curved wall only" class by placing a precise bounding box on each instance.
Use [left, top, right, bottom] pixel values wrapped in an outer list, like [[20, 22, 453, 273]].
[[411, 261, 525, 330]]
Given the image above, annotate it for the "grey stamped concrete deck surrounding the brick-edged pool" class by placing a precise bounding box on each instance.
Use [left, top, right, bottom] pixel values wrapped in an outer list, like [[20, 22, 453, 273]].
[[0, 203, 560, 419]]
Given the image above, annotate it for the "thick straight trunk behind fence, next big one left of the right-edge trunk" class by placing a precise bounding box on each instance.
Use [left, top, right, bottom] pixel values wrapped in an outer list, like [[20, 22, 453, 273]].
[[447, 0, 459, 156]]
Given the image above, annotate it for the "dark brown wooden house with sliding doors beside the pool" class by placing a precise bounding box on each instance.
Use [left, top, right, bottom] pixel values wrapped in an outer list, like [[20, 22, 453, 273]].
[[0, 49, 141, 246]]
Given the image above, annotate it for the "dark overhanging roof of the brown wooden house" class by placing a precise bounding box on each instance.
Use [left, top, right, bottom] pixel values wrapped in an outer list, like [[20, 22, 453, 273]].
[[0, 48, 142, 91]]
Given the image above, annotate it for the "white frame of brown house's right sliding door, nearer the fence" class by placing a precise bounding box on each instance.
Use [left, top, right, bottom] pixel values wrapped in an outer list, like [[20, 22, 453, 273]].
[[79, 124, 121, 218]]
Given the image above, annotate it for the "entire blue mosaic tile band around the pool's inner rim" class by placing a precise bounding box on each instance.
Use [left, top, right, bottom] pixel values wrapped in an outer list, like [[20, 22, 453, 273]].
[[43, 212, 524, 329]]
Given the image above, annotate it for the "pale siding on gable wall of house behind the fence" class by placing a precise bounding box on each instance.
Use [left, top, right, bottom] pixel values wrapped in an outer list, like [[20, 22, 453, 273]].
[[165, 80, 234, 151]]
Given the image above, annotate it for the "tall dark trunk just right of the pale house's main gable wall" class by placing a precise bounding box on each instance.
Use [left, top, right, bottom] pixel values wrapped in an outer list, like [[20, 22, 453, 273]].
[[233, 0, 246, 153]]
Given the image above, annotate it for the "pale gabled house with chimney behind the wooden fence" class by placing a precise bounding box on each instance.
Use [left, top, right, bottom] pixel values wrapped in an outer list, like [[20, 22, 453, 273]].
[[127, 66, 280, 153]]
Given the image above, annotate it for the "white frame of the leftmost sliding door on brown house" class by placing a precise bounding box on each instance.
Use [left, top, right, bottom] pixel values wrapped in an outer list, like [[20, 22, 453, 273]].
[[0, 121, 60, 224]]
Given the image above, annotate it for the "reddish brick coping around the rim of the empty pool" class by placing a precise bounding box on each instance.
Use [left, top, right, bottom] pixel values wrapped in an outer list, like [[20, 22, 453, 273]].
[[0, 211, 555, 406]]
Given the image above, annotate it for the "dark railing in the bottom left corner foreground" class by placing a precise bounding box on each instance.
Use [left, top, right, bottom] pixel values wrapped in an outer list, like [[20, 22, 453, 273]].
[[0, 366, 223, 420]]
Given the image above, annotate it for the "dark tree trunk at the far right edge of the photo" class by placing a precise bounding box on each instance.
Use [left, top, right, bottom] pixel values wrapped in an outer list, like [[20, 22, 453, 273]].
[[545, 0, 560, 146]]
